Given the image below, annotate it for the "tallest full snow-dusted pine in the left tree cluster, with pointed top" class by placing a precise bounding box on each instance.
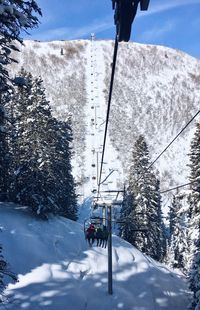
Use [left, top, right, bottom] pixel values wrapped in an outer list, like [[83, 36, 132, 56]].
[[7, 70, 51, 212]]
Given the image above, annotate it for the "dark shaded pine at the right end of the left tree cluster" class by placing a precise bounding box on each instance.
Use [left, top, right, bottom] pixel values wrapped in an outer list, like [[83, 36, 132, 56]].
[[40, 118, 77, 220]]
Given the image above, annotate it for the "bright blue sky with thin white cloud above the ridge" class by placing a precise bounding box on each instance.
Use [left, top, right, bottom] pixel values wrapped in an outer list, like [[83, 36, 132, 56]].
[[25, 0, 200, 57]]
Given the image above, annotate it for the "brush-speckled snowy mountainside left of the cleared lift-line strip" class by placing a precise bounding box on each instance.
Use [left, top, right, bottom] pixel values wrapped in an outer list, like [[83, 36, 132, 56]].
[[12, 41, 88, 188]]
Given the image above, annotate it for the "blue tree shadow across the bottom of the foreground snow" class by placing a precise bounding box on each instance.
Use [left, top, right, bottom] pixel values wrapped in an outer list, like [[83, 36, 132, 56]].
[[0, 262, 189, 310]]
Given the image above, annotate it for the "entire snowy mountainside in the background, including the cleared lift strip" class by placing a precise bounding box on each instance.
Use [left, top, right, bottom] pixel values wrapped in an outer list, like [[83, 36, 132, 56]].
[[9, 40, 200, 197]]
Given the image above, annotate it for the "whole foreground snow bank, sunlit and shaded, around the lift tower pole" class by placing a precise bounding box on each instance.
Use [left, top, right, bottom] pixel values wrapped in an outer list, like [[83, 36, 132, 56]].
[[0, 204, 189, 310]]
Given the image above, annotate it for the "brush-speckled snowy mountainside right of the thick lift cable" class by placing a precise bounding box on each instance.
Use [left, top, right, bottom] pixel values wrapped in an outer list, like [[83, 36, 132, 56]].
[[101, 44, 200, 188]]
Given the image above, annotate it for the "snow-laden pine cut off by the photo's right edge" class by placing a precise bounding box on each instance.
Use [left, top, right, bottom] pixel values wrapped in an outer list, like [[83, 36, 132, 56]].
[[189, 123, 200, 310]]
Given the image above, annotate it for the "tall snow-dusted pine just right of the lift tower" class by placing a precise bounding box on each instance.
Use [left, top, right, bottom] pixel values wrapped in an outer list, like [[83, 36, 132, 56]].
[[129, 135, 165, 260]]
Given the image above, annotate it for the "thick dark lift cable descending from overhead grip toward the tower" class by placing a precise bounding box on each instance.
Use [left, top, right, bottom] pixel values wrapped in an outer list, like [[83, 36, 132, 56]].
[[97, 36, 118, 196]]
